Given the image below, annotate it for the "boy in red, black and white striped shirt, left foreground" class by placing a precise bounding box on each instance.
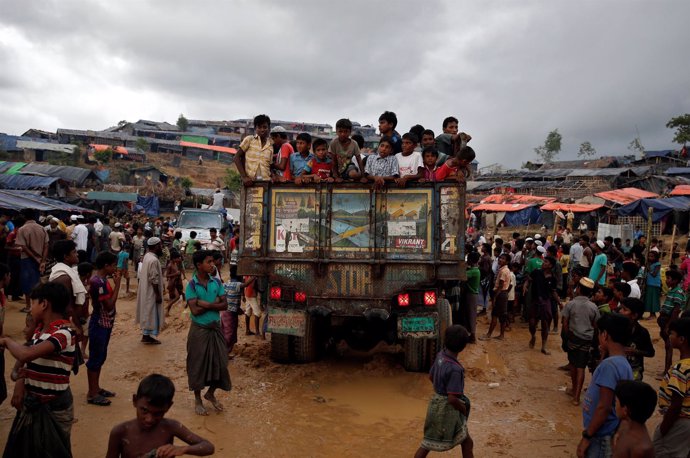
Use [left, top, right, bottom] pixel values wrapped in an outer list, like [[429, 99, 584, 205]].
[[0, 283, 76, 456]]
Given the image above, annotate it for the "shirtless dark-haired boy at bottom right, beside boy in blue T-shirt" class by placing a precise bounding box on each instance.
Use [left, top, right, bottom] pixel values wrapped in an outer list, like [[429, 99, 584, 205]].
[[613, 380, 656, 458]]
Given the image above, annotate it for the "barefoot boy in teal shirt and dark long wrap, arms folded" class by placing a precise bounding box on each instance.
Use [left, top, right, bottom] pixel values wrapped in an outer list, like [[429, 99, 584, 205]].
[[185, 250, 232, 415]]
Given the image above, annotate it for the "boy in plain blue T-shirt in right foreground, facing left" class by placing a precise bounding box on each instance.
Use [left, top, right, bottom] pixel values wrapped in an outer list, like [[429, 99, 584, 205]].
[[577, 313, 633, 458]]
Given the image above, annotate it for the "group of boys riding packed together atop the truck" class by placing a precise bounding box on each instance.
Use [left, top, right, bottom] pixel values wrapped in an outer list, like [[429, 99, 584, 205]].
[[235, 111, 475, 188]]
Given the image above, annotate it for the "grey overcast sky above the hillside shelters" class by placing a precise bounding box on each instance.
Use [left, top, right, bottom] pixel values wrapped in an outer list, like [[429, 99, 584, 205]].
[[0, 0, 690, 167]]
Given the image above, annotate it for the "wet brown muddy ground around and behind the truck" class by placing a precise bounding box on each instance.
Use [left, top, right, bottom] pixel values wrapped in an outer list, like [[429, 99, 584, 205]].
[[0, 280, 663, 457]]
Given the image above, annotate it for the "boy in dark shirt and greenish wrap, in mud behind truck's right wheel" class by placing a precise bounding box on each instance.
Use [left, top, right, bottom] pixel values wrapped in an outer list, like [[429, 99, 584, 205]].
[[414, 324, 474, 458]]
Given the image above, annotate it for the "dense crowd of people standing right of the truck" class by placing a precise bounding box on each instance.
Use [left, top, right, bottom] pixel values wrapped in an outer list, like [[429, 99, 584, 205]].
[[448, 219, 690, 457]]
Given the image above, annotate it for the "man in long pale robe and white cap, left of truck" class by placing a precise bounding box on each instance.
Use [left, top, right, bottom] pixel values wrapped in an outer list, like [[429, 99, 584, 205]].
[[136, 237, 165, 344]]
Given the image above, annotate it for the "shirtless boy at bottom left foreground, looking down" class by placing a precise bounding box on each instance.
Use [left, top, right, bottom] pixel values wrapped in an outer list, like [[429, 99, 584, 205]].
[[106, 374, 215, 458]]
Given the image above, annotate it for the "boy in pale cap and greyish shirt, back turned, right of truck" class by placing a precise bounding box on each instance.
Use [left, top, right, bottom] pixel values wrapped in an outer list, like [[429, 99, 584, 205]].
[[561, 278, 599, 405]]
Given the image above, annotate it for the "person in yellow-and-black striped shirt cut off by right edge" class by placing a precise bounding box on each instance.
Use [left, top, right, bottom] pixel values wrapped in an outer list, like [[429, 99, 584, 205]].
[[654, 317, 690, 458]]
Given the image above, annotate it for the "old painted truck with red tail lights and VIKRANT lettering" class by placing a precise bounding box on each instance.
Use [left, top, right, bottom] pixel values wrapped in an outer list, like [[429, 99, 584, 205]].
[[238, 181, 466, 371]]
